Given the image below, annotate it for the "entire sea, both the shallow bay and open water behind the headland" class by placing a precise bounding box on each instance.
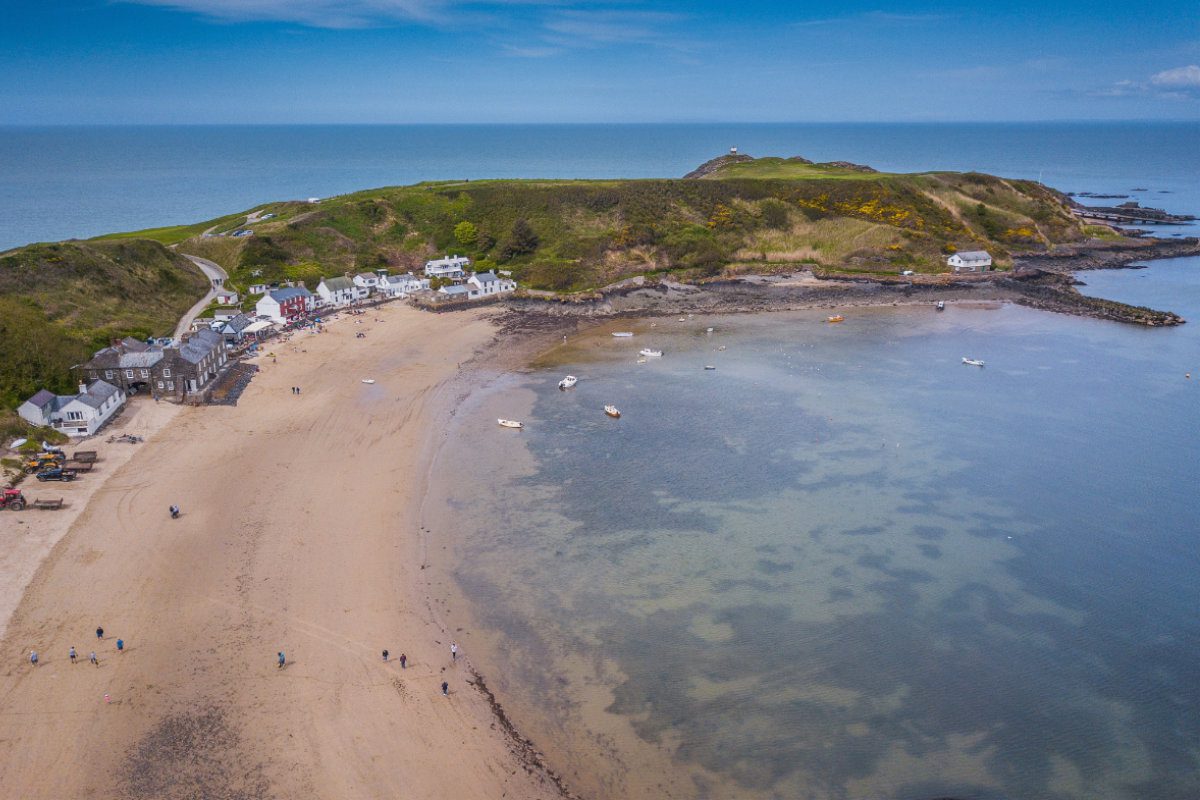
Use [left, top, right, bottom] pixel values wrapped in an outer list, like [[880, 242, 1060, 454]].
[[0, 122, 1200, 800]]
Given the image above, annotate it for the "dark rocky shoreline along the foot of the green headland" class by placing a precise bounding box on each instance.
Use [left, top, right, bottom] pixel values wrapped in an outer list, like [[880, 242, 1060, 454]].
[[494, 239, 1200, 326]]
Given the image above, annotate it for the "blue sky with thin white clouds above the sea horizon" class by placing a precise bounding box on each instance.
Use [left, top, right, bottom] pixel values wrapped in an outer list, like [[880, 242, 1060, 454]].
[[0, 0, 1200, 125]]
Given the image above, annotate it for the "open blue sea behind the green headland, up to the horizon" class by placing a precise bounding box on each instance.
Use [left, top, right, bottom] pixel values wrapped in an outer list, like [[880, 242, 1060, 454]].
[[0, 121, 1200, 251]]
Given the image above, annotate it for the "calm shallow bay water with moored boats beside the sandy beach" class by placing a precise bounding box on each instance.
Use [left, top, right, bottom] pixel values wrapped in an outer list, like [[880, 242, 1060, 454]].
[[439, 259, 1200, 799]]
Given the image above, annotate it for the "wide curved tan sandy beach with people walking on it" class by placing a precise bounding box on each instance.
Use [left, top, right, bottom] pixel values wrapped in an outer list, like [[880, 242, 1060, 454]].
[[0, 305, 560, 799]]
